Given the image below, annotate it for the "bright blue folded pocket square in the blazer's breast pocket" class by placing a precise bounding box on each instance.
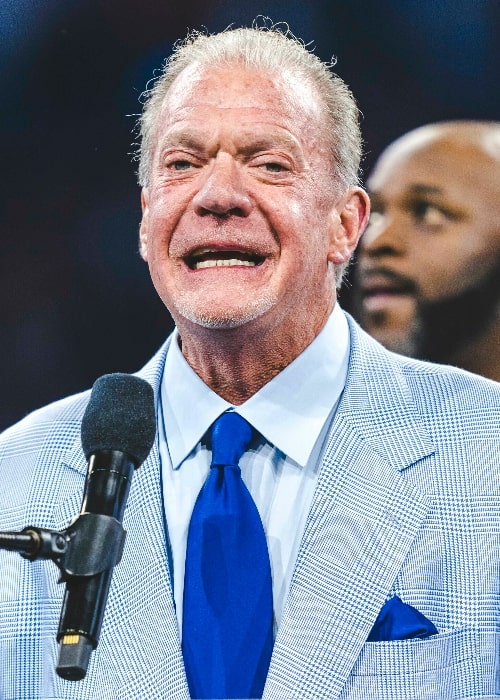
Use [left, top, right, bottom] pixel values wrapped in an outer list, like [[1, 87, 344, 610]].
[[367, 595, 438, 642]]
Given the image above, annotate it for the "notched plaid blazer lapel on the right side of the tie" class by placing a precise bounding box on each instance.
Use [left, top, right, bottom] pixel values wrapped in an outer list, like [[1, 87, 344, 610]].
[[264, 318, 434, 699]]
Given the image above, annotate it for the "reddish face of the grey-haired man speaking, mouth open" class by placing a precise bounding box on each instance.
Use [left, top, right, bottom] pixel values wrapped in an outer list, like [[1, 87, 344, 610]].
[[141, 66, 364, 342]]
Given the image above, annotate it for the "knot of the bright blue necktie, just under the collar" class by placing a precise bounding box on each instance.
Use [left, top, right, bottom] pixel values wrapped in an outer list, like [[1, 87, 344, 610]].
[[210, 411, 252, 467]]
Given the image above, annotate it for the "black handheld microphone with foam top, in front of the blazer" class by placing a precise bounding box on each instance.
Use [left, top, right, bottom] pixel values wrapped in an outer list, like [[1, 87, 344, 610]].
[[56, 373, 156, 680]]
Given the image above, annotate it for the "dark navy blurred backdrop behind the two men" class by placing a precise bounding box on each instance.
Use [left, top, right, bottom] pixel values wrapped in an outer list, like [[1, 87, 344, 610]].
[[0, 0, 500, 428]]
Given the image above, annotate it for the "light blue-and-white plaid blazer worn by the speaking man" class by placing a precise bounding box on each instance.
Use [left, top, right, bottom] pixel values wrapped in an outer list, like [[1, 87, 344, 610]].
[[0, 314, 500, 700]]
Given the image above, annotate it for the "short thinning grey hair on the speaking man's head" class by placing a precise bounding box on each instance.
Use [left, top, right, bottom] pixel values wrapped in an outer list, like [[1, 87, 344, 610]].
[[138, 23, 362, 189]]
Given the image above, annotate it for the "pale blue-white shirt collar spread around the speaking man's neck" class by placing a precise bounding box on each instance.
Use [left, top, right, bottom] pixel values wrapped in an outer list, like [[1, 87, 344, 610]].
[[161, 304, 350, 469]]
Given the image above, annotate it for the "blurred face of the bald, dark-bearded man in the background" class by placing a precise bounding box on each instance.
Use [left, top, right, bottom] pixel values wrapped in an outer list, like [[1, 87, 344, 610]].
[[357, 132, 500, 361]]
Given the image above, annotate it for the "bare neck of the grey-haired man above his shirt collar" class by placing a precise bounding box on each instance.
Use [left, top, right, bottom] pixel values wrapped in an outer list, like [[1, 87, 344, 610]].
[[177, 313, 329, 406]]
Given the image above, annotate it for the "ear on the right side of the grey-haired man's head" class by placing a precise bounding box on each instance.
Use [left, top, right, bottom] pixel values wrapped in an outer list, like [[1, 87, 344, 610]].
[[328, 187, 370, 265]]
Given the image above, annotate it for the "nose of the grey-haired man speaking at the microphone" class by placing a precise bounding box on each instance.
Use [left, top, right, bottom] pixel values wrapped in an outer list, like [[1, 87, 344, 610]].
[[193, 153, 252, 216]]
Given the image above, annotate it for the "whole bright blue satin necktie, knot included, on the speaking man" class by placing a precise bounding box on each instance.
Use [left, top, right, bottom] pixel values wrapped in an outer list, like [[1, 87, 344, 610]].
[[182, 412, 273, 699]]
